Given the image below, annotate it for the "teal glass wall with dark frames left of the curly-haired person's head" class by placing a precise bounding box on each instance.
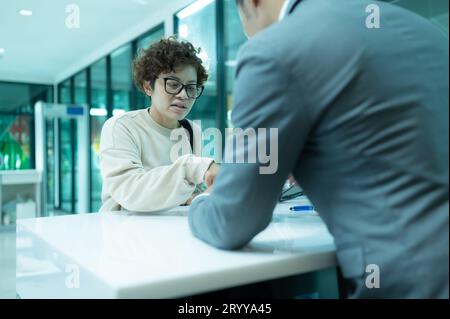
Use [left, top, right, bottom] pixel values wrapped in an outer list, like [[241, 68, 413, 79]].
[[56, 24, 164, 213]]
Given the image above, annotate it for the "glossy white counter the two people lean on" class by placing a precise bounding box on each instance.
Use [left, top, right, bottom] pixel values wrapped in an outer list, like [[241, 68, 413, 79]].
[[16, 202, 336, 298]]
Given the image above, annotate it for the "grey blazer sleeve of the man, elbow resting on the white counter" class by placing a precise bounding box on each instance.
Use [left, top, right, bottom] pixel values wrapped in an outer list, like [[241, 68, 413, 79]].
[[189, 40, 311, 249]]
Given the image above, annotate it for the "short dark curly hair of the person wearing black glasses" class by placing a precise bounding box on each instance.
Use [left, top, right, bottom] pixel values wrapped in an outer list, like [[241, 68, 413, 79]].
[[132, 36, 208, 91]]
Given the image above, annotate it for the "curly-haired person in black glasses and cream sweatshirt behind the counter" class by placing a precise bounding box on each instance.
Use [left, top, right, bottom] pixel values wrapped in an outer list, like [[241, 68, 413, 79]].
[[100, 37, 218, 212]]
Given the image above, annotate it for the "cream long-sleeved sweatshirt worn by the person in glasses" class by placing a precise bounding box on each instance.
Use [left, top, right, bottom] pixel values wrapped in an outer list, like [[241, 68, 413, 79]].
[[100, 108, 212, 212]]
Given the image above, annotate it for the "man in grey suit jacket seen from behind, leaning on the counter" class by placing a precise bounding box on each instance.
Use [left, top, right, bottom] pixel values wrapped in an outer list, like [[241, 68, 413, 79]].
[[189, 0, 449, 298]]
